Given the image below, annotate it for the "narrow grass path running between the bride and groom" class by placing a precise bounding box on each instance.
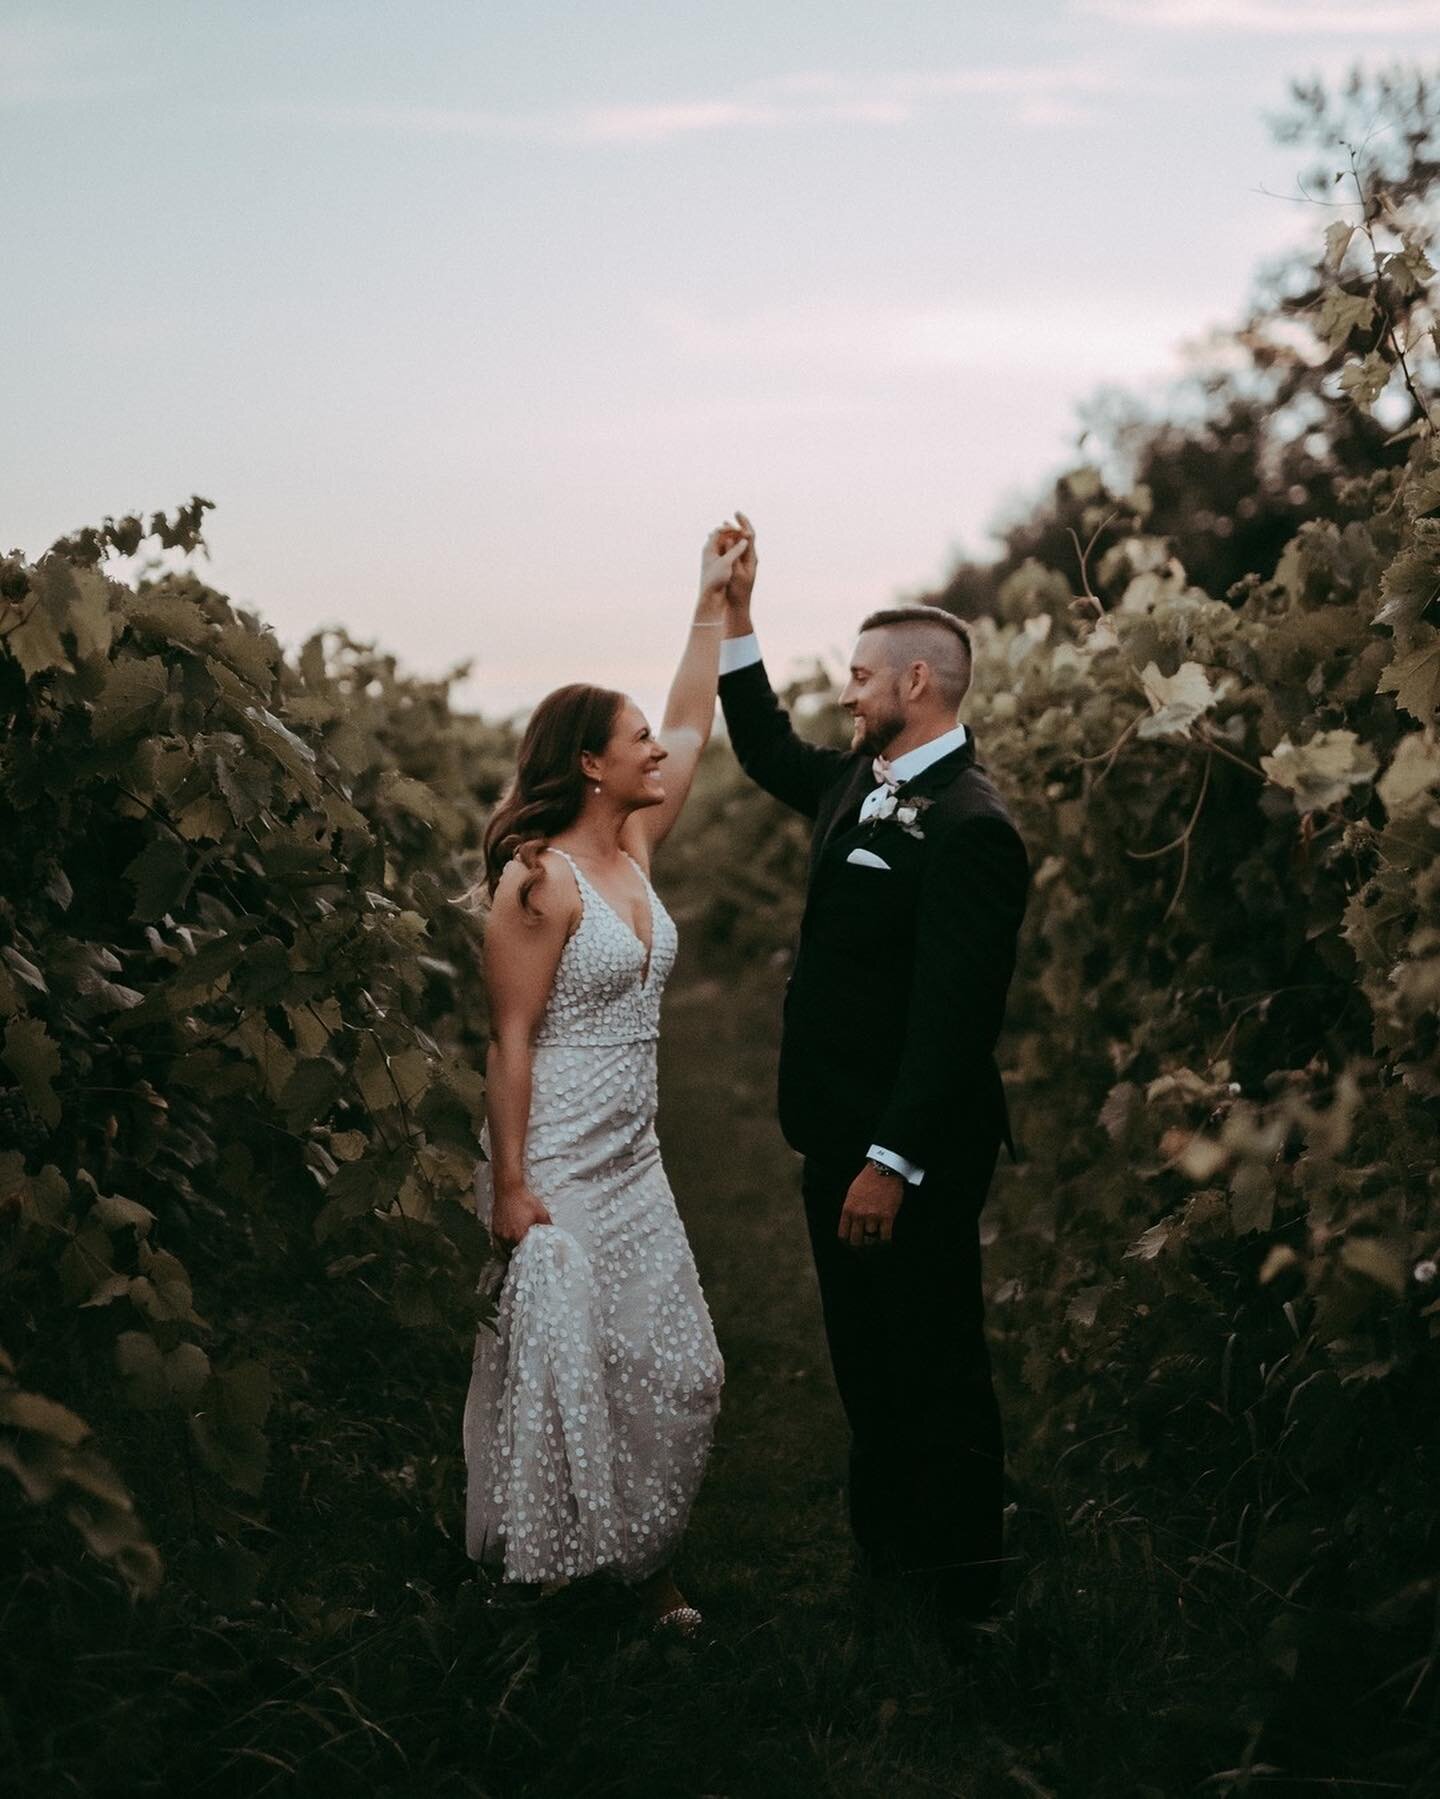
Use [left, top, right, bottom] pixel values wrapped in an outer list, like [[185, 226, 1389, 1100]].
[[464, 970, 1057, 1799]]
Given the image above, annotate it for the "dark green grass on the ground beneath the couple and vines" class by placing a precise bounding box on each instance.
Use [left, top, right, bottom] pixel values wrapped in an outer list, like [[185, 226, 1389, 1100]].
[[0, 959, 1357, 1799]]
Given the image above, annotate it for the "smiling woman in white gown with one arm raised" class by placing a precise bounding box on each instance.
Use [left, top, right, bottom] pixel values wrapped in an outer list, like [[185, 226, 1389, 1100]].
[[464, 515, 751, 1632]]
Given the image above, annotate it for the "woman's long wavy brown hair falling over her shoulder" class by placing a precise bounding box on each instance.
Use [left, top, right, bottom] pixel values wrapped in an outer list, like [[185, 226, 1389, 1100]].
[[484, 682, 625, 910]]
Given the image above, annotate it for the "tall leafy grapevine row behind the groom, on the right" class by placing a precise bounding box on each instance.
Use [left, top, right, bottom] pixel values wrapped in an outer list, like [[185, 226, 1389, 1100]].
[[687, 130, 1440, 1790]]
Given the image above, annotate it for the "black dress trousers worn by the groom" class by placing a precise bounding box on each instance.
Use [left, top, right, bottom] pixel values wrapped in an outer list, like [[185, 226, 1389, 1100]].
[[801, 1144, 1004, 1617]]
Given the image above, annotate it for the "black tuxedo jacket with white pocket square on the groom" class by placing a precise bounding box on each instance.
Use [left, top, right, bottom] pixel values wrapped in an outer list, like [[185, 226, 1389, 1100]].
[[720, 662, 1030, 1180]]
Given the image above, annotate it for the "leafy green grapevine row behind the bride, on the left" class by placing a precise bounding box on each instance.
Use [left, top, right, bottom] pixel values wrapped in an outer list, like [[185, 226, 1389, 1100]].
[[0, 500, 506, 1590]]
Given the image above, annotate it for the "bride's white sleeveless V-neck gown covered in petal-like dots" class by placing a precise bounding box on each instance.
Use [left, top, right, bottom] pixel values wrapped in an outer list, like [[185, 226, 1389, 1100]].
[[464, 851, 724, 1581]]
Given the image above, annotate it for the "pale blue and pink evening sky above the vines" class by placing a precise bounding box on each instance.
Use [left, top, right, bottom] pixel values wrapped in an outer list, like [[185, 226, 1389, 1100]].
[[0, 0, 1440, 711]]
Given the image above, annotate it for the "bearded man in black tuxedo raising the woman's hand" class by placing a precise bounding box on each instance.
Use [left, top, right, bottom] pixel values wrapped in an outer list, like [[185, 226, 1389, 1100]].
[[720, 516, 1030, 1623]]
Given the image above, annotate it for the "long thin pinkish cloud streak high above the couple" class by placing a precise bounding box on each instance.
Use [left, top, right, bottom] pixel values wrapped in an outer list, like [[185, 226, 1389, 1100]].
[[279, 58, 1130, 144]]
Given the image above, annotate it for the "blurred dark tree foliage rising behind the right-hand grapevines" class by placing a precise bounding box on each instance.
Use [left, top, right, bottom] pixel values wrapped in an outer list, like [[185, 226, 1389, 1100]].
[[934, 70, 1440, 621]]
